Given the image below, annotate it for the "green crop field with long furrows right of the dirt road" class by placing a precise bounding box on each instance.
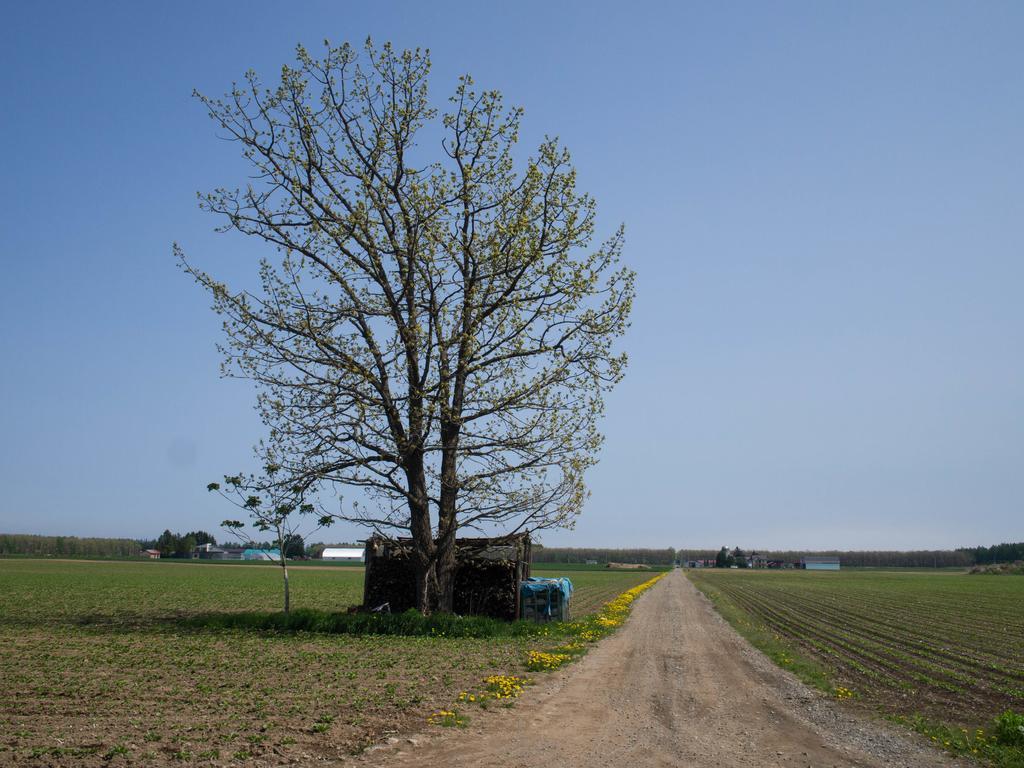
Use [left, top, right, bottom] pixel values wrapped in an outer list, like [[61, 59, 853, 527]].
[[688, 569, 1024, 765]]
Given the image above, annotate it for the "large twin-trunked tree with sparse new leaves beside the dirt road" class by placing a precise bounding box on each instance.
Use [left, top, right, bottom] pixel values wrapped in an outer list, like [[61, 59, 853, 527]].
[[175, 41, 634, 611]]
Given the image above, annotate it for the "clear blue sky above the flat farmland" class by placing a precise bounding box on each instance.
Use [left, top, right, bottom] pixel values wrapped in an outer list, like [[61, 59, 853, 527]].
[[0, 1, 1024, 549]]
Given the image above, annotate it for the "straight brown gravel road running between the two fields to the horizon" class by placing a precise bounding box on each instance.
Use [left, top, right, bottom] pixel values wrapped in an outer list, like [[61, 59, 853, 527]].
[[358, 572, 958, 768]]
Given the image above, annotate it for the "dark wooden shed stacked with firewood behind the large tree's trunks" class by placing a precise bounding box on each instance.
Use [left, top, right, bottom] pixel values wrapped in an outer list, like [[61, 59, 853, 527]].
[[362, 534, 532, 621]]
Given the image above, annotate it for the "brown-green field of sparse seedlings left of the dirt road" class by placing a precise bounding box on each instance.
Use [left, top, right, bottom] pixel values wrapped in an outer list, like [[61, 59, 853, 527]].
[[0, 559, 652, 766]]
